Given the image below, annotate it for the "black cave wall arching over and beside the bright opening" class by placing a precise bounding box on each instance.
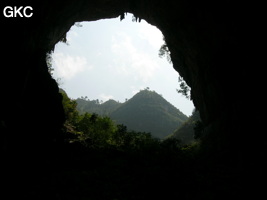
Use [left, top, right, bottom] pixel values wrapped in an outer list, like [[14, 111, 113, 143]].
[[0, 0, 264, 162]]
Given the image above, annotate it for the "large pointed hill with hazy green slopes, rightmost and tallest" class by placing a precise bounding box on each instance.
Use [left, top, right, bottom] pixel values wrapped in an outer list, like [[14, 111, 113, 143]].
[[111, 90, 187, 138]]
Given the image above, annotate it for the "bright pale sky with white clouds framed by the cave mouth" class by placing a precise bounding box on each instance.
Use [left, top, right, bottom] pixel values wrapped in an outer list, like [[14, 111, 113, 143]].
[[52, 14, 194, 116]]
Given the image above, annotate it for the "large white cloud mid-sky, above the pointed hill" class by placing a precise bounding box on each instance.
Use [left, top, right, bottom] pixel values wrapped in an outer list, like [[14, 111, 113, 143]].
[[111, 33, 159, 82]]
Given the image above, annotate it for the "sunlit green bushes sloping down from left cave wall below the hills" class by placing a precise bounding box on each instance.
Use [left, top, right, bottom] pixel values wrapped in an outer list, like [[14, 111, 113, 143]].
[[61, 90, 162, 150]]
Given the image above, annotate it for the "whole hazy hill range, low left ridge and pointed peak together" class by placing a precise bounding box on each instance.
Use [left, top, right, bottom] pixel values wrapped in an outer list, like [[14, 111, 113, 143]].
[[77, 89, 188, 138]]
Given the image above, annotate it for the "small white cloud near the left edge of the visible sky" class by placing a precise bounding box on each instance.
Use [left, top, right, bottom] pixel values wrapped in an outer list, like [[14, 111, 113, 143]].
[[53, 53, 93, 80]]
